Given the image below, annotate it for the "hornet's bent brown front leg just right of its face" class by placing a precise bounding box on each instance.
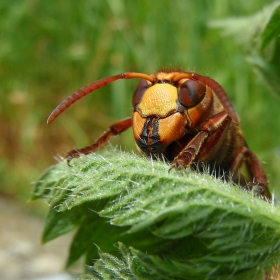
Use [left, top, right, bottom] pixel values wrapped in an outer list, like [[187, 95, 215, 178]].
[[171, 111, 231, 169]]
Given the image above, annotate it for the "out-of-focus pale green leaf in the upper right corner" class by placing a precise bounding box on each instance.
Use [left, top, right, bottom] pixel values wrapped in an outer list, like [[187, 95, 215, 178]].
[[209, 1, 280, 96]]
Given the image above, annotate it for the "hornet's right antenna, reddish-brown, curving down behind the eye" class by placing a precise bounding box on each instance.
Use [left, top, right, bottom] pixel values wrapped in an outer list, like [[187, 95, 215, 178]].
[[173, 72, 239, 123]]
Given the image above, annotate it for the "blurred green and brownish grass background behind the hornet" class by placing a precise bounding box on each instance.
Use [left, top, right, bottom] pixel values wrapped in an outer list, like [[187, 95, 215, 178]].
[[0, 0, 280, 211]]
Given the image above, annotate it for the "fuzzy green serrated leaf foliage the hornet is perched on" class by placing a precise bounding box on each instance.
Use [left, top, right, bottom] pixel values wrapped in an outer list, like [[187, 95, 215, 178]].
[[32, 149, 280, 280]]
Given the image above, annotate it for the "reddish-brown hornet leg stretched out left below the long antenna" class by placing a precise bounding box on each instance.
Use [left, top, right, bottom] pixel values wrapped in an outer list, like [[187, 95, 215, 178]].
[[66, 118, 132, 164]]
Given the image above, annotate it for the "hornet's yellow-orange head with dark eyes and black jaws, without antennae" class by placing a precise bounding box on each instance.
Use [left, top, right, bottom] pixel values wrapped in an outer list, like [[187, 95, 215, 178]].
[[132, 73, 213, 154]]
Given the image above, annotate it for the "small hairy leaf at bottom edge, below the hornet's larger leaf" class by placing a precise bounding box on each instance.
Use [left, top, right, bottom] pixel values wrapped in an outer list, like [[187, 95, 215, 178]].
[[88, 243, 276, 280]]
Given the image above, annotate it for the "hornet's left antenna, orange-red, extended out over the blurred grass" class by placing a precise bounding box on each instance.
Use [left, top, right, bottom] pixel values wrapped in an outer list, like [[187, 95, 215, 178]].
[[47, 72, 155, 124]]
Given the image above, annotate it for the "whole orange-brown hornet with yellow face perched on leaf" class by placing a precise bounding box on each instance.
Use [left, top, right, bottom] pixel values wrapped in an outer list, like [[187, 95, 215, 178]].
[[47, 71, 271, 200]]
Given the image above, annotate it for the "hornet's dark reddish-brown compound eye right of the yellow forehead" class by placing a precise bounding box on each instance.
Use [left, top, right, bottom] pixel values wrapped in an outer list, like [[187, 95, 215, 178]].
[[178, 80, 206, 108]]
